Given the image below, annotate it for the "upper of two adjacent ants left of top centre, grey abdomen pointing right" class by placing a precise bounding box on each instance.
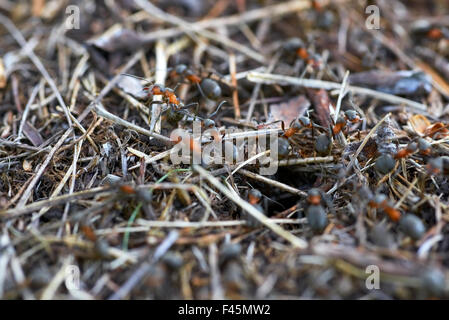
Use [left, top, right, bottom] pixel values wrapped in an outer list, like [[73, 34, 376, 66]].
[[170, 64, 222, 100]]
